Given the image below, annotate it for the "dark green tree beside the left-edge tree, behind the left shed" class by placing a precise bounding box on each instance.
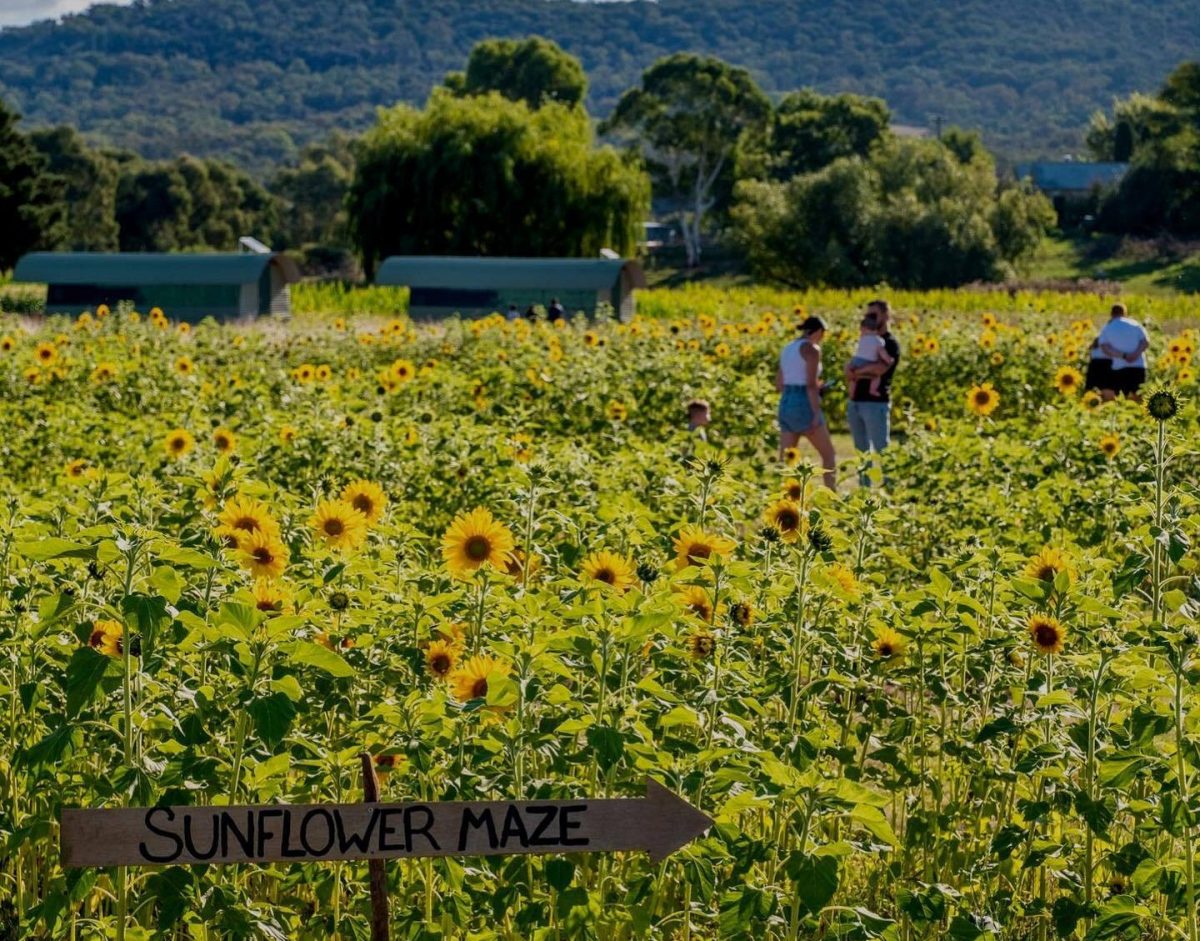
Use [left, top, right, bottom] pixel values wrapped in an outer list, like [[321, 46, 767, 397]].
[[29, 127, 119, 252]]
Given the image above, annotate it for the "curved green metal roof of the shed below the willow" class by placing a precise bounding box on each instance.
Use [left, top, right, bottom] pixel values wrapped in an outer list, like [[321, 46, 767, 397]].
[[376, 254, 646, 290]]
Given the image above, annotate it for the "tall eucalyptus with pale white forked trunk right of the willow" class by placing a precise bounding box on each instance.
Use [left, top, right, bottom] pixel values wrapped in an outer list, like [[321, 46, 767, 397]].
[[605, 53, 770, 266]]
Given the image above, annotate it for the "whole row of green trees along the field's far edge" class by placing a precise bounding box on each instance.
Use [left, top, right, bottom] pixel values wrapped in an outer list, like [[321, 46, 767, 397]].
[[14, 37, 1200, 287]]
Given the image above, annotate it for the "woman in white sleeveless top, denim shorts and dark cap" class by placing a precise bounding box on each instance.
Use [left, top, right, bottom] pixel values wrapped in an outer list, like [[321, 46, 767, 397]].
[[775, 317, 838, 490]]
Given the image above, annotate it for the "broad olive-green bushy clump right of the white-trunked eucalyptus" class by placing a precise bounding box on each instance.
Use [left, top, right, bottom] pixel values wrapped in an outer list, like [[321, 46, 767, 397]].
[[733, 140, 1054, 288]]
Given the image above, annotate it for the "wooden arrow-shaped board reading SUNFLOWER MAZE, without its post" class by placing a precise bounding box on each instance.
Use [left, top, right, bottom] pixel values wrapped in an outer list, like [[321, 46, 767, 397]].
[[61, 779, 713, 868]]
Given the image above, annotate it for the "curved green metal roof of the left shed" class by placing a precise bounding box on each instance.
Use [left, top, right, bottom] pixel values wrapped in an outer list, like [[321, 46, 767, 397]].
[[12, 252, 299, 287]]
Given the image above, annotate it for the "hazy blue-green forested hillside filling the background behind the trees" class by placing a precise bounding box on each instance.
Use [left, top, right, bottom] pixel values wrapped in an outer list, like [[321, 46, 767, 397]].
[[0, 0, 1200, 168]]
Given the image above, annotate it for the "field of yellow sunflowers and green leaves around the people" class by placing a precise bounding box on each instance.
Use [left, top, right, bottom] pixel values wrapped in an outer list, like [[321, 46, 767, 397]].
[[0, 288, 1200, 941]]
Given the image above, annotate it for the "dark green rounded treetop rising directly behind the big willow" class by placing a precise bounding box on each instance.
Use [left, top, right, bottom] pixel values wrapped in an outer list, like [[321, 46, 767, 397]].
[[446, 36, 588, 108]]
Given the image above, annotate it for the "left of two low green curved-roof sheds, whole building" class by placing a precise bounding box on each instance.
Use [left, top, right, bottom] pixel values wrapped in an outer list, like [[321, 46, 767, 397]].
[[13, 252, 300, 323]]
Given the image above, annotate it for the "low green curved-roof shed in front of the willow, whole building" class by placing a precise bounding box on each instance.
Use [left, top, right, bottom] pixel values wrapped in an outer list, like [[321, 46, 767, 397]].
[[376, 256, 646, 320]]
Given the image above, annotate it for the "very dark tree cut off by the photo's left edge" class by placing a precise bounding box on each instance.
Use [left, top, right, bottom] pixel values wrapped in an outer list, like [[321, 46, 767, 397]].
[[0, 101, 64, 270]]
